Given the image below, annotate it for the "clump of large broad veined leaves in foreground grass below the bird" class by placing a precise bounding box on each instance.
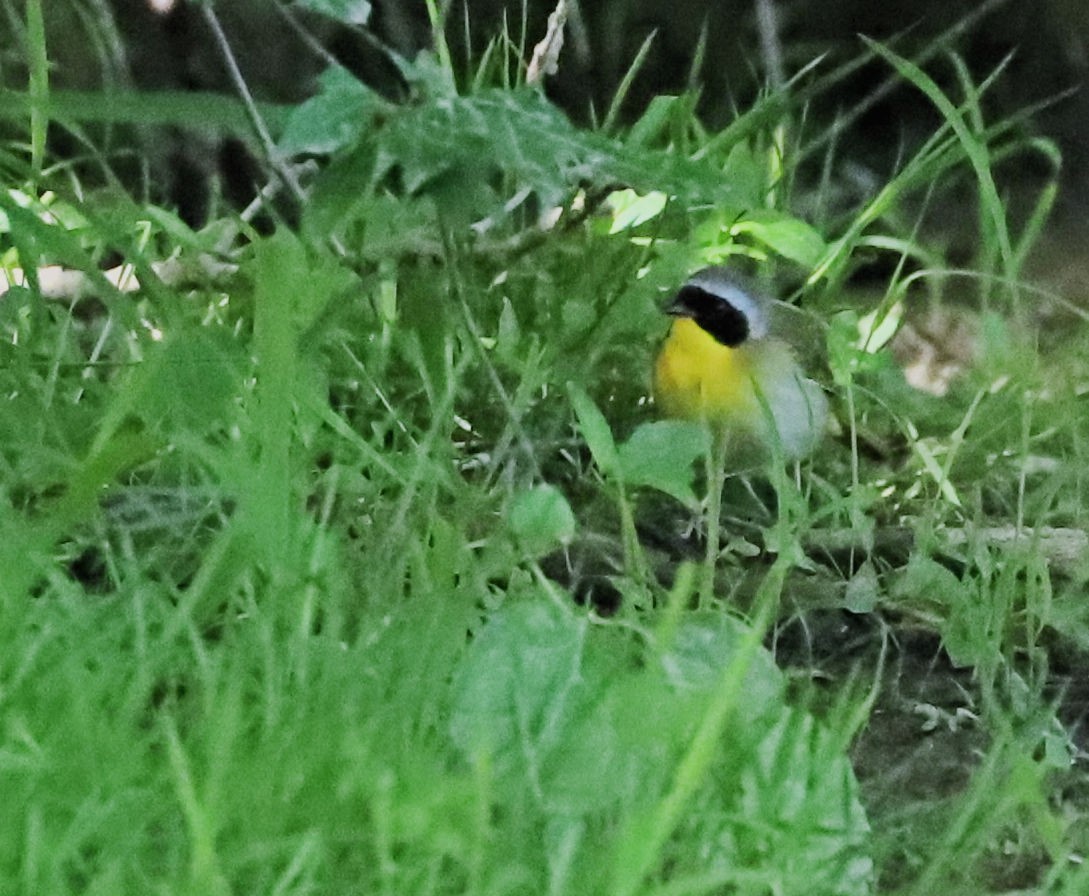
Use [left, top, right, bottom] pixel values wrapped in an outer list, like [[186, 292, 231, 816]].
[[451, 600, 872, 894]]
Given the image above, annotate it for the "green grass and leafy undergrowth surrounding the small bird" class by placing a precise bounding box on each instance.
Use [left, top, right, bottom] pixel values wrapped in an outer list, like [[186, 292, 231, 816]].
[[0, 3, 1089, 896]]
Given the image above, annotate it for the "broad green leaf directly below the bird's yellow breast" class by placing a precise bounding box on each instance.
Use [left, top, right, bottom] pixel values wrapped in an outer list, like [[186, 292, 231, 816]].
[[620, 420, 710, 506]]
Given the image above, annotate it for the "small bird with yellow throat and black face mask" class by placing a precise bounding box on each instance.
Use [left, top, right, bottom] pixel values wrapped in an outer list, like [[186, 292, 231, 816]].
[[653, 267, 828, 458]]
